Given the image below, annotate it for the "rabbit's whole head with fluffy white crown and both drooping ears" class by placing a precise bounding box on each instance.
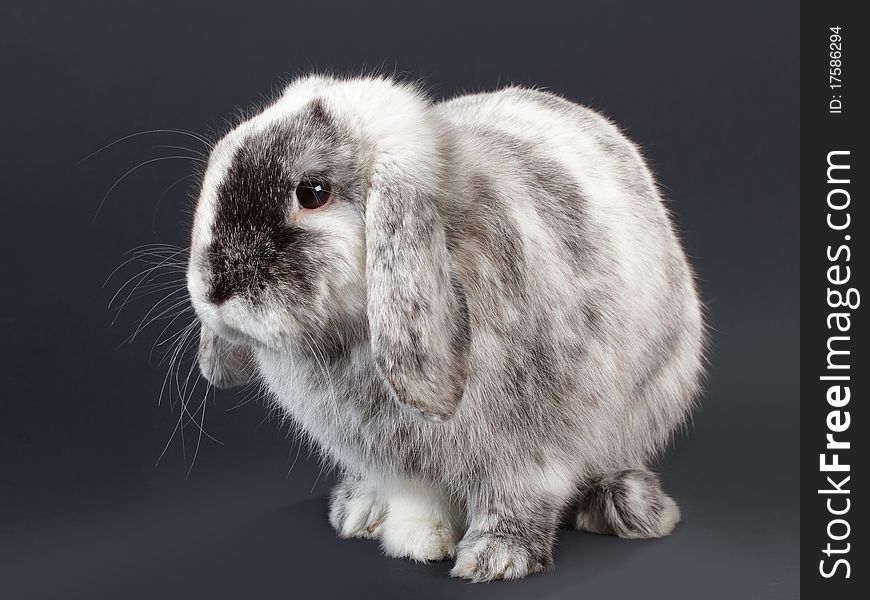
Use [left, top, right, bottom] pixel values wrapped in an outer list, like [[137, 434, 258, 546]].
[[187, 77, 468, 418]]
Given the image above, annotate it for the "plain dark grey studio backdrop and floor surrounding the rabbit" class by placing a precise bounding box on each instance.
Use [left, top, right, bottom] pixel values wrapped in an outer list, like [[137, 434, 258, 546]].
[[0, 0, 799, 599]]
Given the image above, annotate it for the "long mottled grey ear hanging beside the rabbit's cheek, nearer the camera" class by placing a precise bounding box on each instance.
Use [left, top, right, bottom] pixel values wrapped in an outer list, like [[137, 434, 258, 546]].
[[366, 168, 468, 420]]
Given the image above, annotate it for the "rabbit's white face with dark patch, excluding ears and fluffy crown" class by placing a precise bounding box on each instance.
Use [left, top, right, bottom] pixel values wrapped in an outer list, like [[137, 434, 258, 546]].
[[188, 99, 365, 350]]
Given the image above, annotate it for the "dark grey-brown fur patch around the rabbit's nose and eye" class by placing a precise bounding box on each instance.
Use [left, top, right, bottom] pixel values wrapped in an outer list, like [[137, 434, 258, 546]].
[[206, 100, 364, 330]]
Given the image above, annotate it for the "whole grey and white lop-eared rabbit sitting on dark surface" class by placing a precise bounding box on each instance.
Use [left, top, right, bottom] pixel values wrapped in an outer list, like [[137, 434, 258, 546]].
[[187, 74, 705, 582]]
